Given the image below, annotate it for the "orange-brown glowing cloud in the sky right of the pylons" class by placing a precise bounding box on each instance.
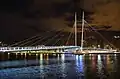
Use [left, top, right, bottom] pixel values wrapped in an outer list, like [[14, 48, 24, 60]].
[[82, 0, 120, 31]]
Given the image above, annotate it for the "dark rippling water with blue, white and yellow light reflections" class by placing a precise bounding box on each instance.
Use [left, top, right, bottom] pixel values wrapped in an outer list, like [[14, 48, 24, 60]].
[[0, 54, 120, 79]]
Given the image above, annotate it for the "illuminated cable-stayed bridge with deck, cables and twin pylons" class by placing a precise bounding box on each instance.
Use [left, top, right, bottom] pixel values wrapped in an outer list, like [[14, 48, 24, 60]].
[[0, 12, 116, 52]]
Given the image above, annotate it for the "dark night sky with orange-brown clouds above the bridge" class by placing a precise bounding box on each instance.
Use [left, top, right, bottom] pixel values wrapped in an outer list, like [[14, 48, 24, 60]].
[[0, 0, 120, 43]]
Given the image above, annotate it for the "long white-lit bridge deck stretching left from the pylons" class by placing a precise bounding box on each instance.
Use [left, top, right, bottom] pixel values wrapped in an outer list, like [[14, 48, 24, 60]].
[[0, 46, 80, 52]]
